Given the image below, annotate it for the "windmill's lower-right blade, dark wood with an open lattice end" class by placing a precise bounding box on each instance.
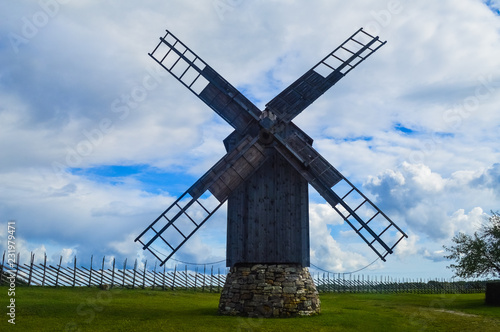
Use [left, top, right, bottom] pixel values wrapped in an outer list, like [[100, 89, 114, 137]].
[[275, 135, 408, 261]]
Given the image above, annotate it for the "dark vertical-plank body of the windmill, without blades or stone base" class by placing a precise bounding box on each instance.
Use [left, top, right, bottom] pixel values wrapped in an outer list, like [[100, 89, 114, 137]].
[[226, 149, 310, 267]]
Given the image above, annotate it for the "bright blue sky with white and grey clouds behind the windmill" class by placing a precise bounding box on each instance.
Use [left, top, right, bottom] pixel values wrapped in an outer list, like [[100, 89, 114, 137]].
[[0, 0, 500, 278]]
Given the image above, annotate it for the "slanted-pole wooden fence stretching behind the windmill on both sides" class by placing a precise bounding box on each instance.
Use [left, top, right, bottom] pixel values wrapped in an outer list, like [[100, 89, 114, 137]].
[[0, 253, 486, 294]]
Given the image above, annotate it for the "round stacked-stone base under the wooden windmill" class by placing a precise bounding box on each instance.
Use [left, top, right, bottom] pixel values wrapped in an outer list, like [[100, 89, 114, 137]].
[[219, 264, 320, 317]]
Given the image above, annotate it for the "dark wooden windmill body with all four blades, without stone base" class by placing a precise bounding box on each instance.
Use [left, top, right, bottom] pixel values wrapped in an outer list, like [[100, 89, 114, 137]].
[[135, 28, 407, 316]]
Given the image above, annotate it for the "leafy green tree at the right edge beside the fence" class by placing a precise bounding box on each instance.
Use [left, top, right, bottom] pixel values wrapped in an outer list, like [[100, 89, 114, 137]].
[[444, 212, 500, 278]]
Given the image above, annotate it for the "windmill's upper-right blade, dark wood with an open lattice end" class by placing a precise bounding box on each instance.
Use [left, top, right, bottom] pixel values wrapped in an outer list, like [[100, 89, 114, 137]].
[[266, 28, 386, 123]]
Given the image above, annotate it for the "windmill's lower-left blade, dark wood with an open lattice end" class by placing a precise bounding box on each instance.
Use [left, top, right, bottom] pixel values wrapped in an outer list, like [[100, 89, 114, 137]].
[[135, 135, 267, 265]]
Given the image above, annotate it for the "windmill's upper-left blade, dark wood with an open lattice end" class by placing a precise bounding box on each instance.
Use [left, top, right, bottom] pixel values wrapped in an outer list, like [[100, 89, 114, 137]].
[[149, 30, 261, 133]]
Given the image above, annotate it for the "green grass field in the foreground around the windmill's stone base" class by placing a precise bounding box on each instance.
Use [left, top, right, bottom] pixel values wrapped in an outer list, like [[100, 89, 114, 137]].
[[0, 287, 500, 332]]
